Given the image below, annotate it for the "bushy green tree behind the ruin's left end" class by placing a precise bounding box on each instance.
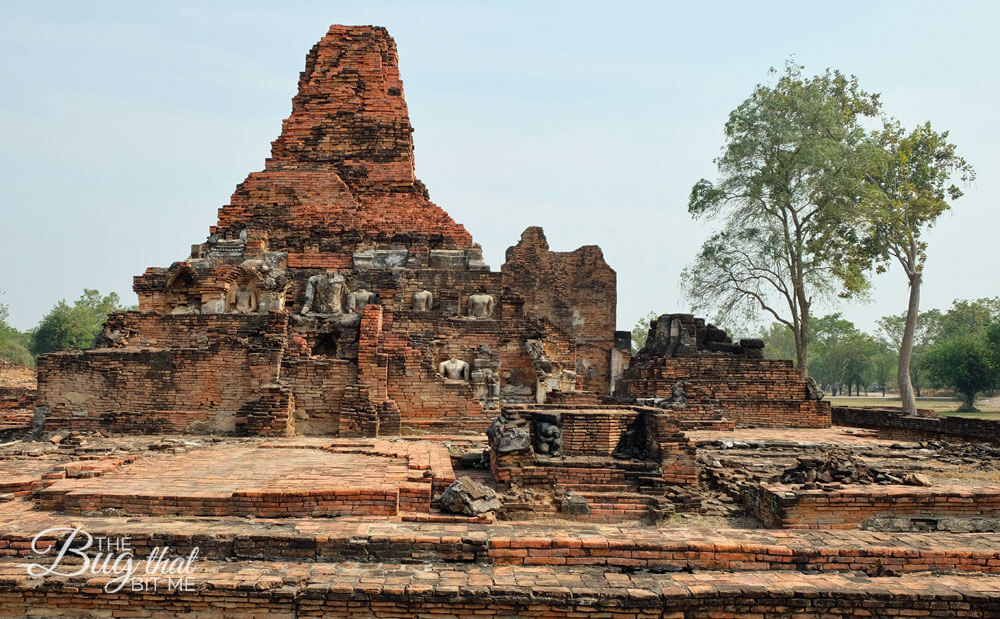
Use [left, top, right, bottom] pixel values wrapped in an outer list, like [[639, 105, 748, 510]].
[[31, 288, 128, 356]]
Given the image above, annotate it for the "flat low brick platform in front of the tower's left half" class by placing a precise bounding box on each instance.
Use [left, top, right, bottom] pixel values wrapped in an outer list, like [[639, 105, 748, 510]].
[[38, 440, 455, 517]]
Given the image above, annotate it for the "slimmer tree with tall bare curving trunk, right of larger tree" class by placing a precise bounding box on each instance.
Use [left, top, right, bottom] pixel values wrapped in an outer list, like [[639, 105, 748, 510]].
[[866, 120, 975, 414]]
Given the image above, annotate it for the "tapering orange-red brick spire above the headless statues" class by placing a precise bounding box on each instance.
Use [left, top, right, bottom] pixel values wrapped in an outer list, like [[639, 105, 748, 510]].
[[212, 26, 473, 266]]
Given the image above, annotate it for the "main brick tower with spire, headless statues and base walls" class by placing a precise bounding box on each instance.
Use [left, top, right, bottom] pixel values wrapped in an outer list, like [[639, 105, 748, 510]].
[[38, 26, 620, 435]]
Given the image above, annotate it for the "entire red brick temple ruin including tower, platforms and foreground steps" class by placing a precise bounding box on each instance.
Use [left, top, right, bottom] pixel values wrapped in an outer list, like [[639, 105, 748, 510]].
[[0, 26, 1000, 618]]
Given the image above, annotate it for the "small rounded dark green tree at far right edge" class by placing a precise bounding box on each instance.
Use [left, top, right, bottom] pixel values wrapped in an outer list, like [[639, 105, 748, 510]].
[[922, 333, 1000, 411]]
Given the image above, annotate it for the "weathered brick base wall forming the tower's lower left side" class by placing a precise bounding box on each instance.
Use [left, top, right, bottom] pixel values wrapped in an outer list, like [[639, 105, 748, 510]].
[[38, 312, 287, 430]]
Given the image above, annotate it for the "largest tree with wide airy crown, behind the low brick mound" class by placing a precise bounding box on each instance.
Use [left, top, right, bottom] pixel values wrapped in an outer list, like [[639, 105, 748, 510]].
[[682, 63, 880, 375]]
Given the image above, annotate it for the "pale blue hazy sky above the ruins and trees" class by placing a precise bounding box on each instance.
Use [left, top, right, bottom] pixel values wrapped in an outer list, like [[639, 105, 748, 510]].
[[0, 0, 1000, 329]]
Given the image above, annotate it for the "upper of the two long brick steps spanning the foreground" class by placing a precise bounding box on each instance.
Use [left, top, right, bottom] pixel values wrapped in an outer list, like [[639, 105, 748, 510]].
[[0, 501, 1000, 574]]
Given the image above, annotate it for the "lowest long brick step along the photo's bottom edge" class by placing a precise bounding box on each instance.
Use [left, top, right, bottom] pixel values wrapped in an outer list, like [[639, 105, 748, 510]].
[[0, 561, 1000, 618]]
